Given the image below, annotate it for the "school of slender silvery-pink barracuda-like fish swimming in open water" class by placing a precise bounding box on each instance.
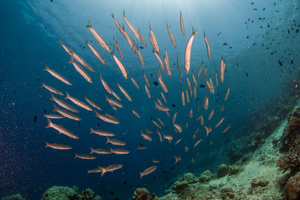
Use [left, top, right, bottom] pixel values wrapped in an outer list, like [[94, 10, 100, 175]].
[[42, 11, 231, 178]]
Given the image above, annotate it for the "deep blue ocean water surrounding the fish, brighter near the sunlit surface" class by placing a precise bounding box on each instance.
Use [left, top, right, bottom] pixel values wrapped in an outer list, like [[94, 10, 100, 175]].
[[0, 0, 300, 199]]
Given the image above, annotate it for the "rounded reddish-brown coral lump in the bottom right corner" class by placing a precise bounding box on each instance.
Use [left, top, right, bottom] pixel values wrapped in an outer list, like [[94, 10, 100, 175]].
[[284, 172, 300, 200]]
